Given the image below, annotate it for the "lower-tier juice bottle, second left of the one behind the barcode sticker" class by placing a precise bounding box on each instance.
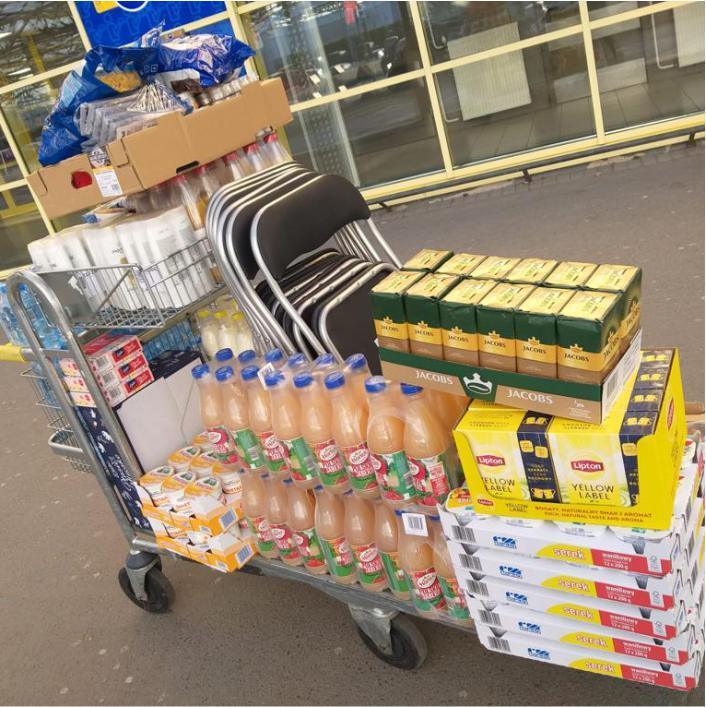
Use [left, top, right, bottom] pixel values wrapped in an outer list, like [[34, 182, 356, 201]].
[[343, 491, 387, 592]]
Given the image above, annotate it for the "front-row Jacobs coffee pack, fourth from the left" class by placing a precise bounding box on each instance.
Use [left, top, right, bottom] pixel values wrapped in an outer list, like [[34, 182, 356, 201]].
[[476, 282, 535, 371]]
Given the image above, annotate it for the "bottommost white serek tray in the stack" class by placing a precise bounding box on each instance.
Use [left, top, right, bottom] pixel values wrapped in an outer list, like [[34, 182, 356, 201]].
[[477, 624, 703, 690]]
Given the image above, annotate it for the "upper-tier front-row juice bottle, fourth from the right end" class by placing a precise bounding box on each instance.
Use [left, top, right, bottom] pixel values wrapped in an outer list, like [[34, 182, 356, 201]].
[[293, 372, 350, 493]]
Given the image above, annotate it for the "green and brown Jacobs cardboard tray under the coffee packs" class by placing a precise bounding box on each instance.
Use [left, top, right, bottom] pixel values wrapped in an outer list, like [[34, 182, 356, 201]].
[[378, 332, 642, 424]]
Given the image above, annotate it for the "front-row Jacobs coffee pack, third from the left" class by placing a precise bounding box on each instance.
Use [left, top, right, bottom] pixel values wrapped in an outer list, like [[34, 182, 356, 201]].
[[439, 276, 496, 366]]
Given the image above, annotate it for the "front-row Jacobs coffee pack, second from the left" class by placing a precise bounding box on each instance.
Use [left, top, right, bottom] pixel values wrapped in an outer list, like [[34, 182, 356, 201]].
[[404, 273, 459, 359]]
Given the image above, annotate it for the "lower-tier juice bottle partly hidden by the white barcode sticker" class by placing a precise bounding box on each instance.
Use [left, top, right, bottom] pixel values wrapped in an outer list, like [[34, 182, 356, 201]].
[[395, 510, 446, 614]]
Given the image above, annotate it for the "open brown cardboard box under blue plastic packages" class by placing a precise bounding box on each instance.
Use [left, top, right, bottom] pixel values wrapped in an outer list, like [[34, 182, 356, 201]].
[[27, 79, 291, 218]]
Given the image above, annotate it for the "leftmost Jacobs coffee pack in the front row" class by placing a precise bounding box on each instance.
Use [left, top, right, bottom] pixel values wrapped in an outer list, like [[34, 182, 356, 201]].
[[370, 270, 424, 352]]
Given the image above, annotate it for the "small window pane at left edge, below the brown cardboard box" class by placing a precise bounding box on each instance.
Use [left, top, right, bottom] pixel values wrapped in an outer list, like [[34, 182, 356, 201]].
[[0, 187, 47, 270]]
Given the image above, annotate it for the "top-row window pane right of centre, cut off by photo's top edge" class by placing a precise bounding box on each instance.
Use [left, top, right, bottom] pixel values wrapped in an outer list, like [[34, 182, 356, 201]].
[[420, 1, 579, 63]]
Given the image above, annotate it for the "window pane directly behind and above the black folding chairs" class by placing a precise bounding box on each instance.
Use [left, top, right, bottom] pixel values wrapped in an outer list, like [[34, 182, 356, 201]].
[[286, 80, 443, 187]]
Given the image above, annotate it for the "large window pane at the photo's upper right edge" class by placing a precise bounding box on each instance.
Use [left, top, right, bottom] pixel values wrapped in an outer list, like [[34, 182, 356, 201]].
[[592, 2, 704, 130]]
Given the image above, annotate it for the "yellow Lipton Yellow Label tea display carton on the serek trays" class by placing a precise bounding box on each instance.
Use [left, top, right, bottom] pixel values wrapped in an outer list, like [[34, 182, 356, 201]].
[[454, 351, 686, 530]]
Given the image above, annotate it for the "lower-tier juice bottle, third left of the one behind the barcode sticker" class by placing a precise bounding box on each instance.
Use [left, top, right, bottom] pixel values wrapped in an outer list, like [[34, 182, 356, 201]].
[[314, 485, 358, 584]]
